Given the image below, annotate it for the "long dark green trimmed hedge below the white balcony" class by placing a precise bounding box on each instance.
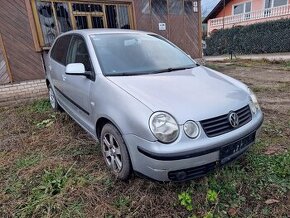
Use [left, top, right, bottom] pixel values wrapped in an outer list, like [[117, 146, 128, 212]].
[[205, 19, 290, 55]]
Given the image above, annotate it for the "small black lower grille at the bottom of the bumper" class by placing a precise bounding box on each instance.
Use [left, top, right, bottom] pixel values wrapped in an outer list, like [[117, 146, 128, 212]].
[[168, 162, 217, 181]]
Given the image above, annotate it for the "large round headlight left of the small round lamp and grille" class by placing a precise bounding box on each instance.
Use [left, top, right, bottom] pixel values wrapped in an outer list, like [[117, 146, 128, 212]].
[[149, 112, 179, 143]]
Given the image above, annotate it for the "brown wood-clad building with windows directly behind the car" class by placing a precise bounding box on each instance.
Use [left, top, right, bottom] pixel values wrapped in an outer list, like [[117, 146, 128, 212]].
[[0, 0, 202, 84]]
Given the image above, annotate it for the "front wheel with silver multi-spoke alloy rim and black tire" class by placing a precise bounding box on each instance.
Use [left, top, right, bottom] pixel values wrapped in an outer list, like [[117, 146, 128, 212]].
[[100, 123, 132, 180]]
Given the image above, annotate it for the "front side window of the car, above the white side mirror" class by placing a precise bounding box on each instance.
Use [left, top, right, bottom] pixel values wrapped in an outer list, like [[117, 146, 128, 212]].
[[67, 36, 92, 71]]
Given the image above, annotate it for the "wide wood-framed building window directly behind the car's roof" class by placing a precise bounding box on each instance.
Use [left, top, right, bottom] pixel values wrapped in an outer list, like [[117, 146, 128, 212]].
[[31, 0, 134, 48]]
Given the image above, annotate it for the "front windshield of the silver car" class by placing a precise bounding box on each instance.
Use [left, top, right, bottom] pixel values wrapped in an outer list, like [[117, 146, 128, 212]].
[[91, 33, 196, 76]]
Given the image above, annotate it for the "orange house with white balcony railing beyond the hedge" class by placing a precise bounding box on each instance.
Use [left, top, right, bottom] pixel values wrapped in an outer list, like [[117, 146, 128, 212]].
[[203, 0, 290, 35]]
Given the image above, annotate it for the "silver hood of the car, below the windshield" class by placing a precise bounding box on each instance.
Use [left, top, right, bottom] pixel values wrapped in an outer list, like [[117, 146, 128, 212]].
[[108, 66, 249, 124]]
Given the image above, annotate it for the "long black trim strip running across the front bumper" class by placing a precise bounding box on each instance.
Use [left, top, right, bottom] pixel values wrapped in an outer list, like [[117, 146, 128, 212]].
[[138, 115, 264, 161]]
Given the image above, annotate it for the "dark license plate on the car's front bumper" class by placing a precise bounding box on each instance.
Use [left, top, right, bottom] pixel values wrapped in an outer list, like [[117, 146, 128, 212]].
[[220, 132, 256, 164]]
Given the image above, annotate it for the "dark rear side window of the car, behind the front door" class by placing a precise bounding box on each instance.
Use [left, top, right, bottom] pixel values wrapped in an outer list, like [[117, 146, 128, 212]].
[[50, 35, 71, 65]]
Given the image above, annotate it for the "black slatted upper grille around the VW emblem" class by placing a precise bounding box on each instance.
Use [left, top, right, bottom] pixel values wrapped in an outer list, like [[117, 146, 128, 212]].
[[200, 105, 252, 137]]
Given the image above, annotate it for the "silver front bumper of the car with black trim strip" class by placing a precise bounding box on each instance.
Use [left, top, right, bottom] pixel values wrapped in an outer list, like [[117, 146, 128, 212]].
[[123, 112, 263, 181]]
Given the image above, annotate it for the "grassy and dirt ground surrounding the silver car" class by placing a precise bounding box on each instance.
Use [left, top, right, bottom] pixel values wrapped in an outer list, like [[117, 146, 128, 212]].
[[0, 60, 290, 218]]
